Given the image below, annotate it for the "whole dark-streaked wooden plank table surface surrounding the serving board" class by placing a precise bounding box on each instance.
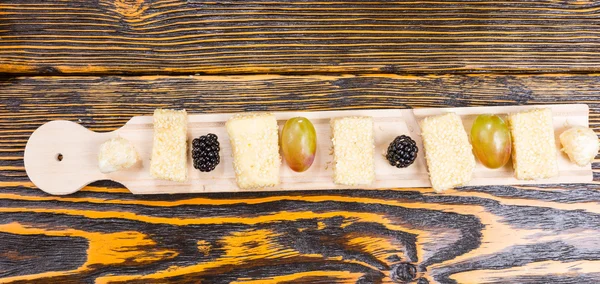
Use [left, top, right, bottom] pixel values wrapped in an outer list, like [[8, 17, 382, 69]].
[[0, 0, 600, 284]]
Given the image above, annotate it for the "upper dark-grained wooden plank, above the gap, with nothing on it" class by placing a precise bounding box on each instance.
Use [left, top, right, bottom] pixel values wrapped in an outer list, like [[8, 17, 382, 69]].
[[0, 0, 600, 74]]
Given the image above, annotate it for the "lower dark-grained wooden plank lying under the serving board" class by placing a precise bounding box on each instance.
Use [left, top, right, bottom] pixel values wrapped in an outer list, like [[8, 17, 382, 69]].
[[0, 74, 600, 283]]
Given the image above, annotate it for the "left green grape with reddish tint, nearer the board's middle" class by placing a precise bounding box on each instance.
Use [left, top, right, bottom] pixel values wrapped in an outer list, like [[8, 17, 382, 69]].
[[281, 117, 317, 172]]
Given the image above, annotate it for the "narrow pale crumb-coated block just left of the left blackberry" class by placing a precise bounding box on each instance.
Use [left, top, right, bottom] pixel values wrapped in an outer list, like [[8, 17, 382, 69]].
[[150, 109, 188, 182]]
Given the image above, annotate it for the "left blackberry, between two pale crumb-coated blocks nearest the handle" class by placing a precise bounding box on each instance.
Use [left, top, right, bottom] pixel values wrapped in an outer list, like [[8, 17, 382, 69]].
[[192, 133, 221, 172]]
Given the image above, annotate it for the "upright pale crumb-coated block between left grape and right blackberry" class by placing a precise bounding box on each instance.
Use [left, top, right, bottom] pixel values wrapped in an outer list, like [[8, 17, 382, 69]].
[[331, 117, 375, 185]]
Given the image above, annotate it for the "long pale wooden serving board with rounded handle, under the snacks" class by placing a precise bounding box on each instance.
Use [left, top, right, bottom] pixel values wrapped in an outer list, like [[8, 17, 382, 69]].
[[25, 104, 592, 195]]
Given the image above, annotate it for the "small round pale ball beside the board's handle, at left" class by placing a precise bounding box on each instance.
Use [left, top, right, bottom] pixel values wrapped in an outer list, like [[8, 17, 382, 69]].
[[98, 137, 139, 174]]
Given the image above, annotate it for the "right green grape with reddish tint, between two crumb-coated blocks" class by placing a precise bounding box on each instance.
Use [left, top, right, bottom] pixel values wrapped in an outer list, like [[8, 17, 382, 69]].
[[471, 114, 512, 169]]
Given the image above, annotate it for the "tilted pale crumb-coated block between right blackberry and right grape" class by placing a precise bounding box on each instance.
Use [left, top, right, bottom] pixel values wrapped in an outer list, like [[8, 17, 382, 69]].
[[420, 113, 475, 192]]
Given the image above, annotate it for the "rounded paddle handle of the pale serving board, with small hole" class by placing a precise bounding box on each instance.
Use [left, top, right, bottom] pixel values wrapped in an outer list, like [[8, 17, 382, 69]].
[[25, 120, 116, 195]]
